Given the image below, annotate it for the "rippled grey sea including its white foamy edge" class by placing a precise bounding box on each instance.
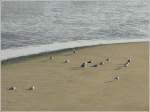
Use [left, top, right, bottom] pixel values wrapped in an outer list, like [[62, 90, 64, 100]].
[[1, 0, 150, 60]]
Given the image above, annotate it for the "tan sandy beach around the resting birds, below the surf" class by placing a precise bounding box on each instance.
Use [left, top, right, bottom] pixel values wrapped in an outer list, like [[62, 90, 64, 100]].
[[1, 42, 149, 111]]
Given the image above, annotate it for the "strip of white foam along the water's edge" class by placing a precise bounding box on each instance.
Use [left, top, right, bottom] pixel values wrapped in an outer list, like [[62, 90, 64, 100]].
[[1, 39, 150, 60]]
